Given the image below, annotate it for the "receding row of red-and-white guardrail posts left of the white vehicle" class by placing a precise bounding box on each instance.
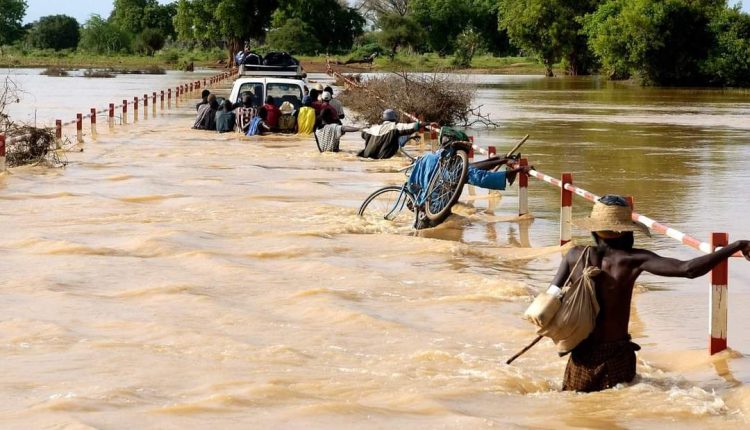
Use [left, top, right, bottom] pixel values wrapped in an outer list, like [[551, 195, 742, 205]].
[[0, 70, 234, 174]]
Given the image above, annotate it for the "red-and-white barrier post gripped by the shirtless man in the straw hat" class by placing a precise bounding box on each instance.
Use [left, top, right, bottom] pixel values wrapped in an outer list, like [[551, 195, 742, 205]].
[[708, 233, 729, 355]]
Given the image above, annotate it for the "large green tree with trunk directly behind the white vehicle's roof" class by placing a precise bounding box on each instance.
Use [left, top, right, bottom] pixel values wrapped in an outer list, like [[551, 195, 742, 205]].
[[174, 0, 276, 64]]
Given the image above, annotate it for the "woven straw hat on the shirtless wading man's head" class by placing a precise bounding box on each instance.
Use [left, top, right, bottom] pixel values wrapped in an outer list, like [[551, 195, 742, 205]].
[[573, 195, 651, 236]]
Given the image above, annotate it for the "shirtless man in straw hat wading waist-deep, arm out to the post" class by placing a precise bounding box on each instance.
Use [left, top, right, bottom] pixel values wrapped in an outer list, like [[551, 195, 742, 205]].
[[552, 195, 750, 392]]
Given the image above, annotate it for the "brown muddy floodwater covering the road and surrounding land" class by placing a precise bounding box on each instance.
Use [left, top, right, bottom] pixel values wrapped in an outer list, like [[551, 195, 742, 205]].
[[0, 70, 750, 429]]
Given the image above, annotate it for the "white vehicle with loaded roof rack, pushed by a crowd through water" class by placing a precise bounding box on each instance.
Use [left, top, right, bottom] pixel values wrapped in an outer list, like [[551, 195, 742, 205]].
[[229, 65, 307, 110]]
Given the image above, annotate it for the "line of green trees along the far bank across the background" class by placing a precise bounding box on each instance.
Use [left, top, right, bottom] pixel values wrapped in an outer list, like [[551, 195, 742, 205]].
[[0, 0, 750, 86]]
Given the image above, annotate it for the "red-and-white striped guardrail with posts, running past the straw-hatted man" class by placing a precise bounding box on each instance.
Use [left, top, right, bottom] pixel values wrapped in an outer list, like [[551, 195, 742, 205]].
[[508, 158, 742, 355]]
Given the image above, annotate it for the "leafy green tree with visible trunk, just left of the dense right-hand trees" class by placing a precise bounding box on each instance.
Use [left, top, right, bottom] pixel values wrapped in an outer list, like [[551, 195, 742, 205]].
[[498, 0, 599, 76]]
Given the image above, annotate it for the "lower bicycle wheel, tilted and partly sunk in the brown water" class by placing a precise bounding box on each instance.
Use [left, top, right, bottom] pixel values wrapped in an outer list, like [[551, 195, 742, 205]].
[[357, 185, 416, 226]]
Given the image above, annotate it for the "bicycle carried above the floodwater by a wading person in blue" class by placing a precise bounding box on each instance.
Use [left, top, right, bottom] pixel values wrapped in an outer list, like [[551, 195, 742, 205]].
[[357, 127, 528, 230]]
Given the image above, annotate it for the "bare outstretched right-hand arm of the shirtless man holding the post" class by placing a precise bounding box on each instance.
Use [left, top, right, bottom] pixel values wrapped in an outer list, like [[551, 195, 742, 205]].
[[634, 240, 750, 279]]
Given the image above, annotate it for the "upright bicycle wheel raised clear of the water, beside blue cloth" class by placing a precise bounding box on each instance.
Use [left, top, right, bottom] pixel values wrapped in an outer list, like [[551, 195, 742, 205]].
[[424, 149, 469, 225]]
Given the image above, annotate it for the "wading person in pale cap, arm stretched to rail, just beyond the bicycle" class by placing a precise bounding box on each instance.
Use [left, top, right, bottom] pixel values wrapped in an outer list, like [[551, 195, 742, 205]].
[[357, 109, 419, 159]]
